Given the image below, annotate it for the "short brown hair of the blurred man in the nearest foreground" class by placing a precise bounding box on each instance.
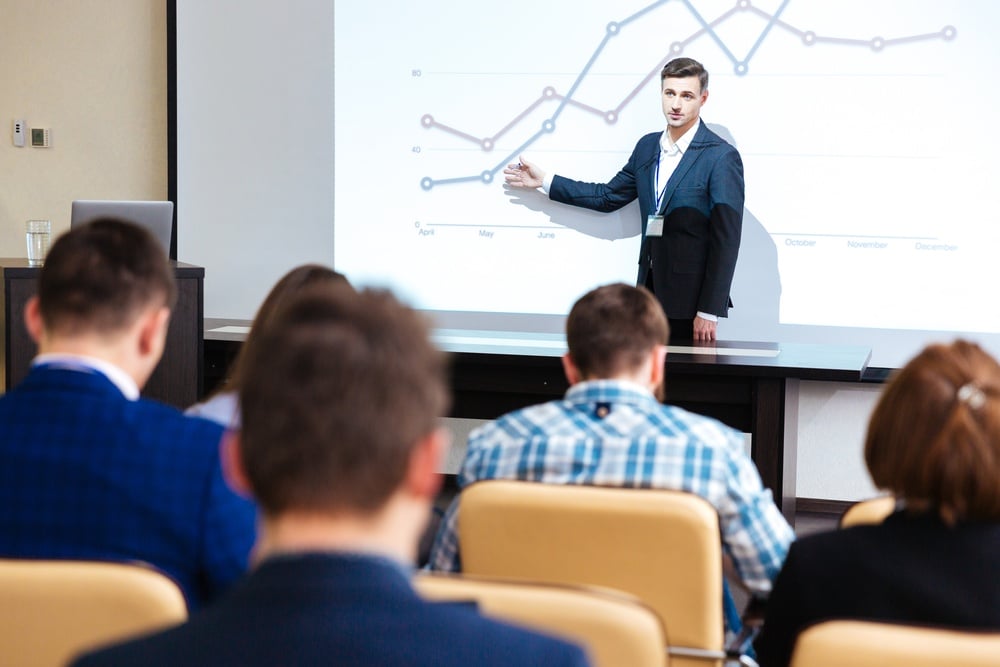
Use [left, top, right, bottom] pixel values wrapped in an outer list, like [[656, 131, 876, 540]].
[[239, 285, 448, 516]]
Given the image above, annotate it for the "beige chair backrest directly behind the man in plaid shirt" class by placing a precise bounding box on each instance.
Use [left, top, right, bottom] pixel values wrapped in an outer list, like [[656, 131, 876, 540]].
[[458, 480, 724, 664]]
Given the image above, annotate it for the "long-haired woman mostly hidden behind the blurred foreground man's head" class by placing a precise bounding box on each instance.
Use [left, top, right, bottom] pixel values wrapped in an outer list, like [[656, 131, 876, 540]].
[[186, 264, 350, 428]]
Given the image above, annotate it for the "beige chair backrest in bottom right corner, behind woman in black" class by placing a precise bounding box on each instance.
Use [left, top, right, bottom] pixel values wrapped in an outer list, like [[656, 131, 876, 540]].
[[791, 621, 1000, 667]]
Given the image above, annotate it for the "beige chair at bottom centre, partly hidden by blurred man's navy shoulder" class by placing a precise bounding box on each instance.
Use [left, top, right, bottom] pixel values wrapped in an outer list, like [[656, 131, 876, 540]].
[[413, 574, 667, 667]]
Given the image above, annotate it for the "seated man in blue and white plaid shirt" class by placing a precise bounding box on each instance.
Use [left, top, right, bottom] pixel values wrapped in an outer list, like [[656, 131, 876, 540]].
[[430, 284, 793, 620]]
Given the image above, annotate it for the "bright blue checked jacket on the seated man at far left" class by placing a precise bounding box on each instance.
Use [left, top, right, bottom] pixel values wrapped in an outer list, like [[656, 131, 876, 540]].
[[0, 366, 256, 607]]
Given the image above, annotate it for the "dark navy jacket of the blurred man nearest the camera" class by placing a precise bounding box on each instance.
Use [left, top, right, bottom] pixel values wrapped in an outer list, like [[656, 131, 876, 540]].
[[75, 553, 586, 667]]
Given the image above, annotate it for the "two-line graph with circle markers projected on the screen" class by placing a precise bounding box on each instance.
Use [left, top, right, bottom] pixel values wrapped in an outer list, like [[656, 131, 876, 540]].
[[420, 0, 958, 190]]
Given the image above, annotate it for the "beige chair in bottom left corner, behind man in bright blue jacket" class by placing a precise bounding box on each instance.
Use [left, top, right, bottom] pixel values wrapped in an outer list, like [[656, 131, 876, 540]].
[[0, 560, 187, 667]]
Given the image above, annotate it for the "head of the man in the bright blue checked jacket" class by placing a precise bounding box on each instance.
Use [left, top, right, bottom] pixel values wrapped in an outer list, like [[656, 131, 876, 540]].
[[25, 219, 176, 386]]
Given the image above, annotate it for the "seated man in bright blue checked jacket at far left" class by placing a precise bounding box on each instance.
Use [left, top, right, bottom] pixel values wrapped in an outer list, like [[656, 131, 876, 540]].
[[0, 220, 255, 607]]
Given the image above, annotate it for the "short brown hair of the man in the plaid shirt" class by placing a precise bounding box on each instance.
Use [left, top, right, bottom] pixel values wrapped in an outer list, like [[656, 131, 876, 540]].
[[566, 283, 670, 378]]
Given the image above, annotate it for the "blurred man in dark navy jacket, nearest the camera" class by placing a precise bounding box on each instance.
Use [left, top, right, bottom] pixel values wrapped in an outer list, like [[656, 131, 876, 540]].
[[77, 285, 585, 667]]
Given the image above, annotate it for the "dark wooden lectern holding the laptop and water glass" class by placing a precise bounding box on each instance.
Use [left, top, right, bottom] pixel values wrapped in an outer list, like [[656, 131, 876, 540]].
[[0, 258, 205, 408]]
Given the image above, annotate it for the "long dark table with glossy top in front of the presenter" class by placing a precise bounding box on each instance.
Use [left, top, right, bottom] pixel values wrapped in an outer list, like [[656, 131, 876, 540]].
[[205, 318, 871, 522]]
